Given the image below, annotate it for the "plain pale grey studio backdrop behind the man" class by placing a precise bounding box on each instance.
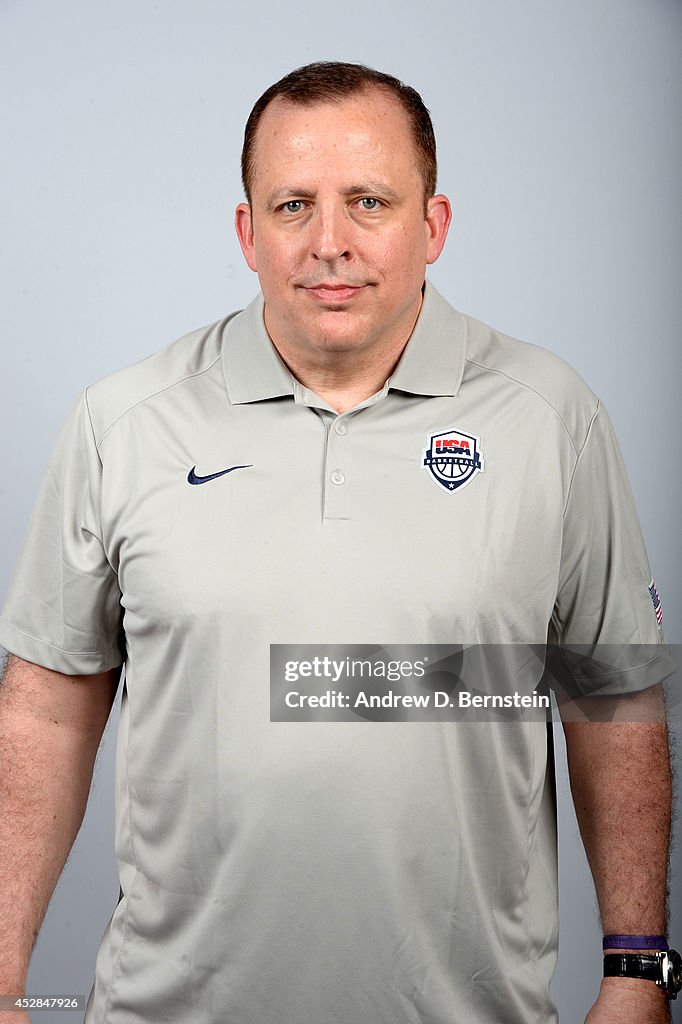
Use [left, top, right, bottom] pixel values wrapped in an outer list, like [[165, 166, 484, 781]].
[[0, 0, 682, 1024]]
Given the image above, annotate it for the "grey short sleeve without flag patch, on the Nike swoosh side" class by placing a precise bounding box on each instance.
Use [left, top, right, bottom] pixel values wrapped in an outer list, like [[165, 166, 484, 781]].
[[0, 392, 125, 675]]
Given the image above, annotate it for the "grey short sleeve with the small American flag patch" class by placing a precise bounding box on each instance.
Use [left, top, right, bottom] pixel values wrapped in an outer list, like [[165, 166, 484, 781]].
[[550, 406, 675, 694]]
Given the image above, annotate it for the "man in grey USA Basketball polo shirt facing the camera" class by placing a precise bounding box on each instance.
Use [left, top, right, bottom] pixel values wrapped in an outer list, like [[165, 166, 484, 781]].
[[0, 63, 672, 1024]]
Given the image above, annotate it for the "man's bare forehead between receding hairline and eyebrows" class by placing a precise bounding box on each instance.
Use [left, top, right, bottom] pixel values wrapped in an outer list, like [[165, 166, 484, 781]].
[[253, 89, 419, 190]]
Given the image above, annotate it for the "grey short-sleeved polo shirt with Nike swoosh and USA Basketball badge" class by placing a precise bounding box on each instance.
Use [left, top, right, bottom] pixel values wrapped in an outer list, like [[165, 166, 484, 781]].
[[0, 284, 671, 1024]]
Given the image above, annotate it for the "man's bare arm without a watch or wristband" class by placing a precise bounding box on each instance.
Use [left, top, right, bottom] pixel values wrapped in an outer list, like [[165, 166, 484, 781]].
[[0, 656, 119, 1003]]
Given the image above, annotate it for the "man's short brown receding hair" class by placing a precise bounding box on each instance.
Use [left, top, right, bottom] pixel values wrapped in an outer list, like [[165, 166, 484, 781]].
[[242, 60, 436, 211]]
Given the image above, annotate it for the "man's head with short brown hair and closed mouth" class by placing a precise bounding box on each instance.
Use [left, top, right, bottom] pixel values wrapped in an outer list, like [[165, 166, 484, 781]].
[[236, 65, 451, 370]]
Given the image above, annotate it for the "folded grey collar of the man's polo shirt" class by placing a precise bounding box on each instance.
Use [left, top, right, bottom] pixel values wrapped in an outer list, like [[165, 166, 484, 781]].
[[222, 281, 467, 406]]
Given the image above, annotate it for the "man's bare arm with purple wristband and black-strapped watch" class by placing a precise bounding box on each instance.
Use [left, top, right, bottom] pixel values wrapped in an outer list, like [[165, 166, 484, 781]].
[[563, 687, 672, 1024]]
